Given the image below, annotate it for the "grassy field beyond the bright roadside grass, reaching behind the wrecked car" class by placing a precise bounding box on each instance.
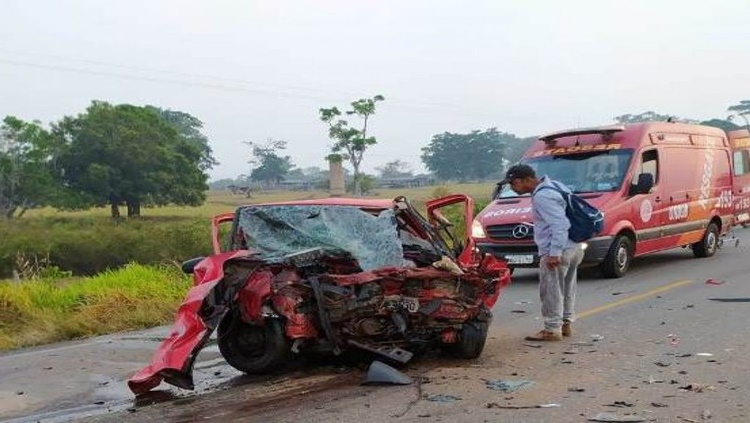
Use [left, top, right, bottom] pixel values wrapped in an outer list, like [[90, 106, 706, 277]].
[[0, 183, 500, 279]]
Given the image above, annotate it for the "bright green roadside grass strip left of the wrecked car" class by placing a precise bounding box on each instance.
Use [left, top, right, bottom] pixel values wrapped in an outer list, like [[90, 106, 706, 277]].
[[0, 264, 191, 350]]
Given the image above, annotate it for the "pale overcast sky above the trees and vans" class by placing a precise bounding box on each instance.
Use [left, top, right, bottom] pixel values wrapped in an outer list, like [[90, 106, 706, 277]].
[[0, 0, 750, 179]]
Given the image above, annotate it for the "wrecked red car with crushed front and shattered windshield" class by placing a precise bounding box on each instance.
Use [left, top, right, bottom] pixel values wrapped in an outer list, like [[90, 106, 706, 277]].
[[128, 195, 510, 394]]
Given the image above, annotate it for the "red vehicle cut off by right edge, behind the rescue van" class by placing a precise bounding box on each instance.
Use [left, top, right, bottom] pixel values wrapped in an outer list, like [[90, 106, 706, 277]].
[[728, 129, 750, 227]]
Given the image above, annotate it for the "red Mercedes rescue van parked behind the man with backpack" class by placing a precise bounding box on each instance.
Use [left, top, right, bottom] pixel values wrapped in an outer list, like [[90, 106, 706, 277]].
[[472, 122, 750, 277]]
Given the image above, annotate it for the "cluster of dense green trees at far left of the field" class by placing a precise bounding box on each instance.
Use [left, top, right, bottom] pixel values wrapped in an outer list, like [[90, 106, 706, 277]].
[[0, 101, 216, 219]]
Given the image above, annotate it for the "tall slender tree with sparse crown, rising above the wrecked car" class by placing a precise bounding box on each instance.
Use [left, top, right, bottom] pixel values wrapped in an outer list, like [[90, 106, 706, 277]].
[[319, 95, 385, 195]]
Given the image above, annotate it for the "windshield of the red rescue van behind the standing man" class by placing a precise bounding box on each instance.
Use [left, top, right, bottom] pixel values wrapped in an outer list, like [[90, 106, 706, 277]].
[[498, 149, 633, 198]]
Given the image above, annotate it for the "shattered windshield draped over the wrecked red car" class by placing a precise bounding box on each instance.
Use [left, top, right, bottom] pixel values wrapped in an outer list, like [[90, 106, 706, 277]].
[[234, 205, 404, 271]]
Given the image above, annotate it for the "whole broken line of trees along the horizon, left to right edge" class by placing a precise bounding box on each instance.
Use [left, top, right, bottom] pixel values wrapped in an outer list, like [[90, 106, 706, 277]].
[[7, 95, 750, 219]]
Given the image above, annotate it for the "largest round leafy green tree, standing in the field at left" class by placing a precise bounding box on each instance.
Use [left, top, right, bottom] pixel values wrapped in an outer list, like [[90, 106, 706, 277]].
[[53, 101, 214, 217]]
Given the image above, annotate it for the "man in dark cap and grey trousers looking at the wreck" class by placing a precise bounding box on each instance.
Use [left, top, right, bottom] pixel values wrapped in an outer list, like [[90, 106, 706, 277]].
[[505, 165, 584, 341]]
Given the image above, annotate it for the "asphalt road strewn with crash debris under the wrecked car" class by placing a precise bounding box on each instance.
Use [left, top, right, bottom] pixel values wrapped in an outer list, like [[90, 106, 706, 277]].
[[0, 229, 750, 423]]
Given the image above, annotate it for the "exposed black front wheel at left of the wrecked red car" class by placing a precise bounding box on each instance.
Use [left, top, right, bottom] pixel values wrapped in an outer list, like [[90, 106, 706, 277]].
[[218, 312, 290, 374]]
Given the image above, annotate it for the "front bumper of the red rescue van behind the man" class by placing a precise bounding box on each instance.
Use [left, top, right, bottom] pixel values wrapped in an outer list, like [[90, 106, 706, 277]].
[[477, 236, 614, 269]]
